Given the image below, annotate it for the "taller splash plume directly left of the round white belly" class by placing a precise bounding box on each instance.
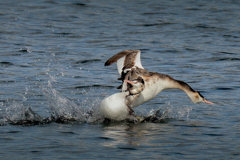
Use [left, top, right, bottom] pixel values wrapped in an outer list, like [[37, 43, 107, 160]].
[[43, 78, 103, 123]]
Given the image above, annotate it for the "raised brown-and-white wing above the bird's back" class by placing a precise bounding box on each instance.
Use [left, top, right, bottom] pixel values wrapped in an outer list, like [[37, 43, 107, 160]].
[[105, 50, 143, 75]]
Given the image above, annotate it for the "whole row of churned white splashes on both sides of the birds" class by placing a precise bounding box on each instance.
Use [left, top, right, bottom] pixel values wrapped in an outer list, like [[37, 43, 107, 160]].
[[0, 83, 191, 125]]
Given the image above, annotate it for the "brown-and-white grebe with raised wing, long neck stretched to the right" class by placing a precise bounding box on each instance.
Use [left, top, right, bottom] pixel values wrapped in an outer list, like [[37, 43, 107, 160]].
[[105, 50, 213, 107]]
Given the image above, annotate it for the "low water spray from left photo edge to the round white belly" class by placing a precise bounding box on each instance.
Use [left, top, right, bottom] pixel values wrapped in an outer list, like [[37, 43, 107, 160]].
[[0, 88, 104, 125]]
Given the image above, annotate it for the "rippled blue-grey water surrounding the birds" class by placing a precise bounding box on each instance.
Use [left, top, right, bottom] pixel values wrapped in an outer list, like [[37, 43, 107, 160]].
[[0, 0, 240, 159]]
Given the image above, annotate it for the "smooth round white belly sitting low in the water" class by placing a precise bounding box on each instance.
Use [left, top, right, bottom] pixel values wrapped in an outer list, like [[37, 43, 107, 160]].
[[100, 92, 129, 121]]
